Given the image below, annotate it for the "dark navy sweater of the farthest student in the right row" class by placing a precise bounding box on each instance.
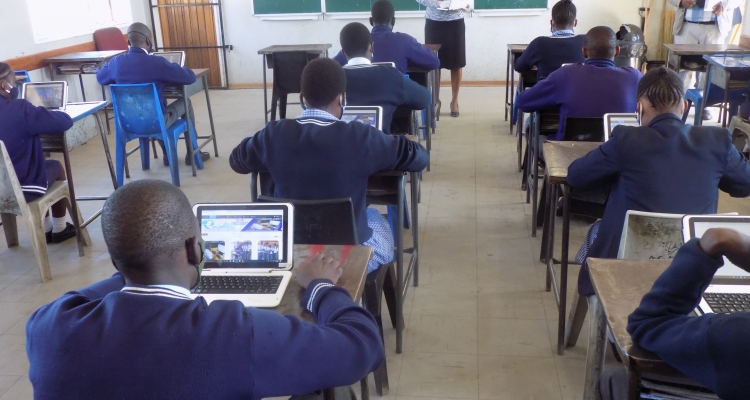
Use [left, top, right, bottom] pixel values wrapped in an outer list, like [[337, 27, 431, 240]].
[[514, 35, 586, 78]]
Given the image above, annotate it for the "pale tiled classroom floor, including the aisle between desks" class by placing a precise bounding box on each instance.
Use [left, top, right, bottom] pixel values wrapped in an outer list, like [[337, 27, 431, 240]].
[[0, 88, 750, 400]]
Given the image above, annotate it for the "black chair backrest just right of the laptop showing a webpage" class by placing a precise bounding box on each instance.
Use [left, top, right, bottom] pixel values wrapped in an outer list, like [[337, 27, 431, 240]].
[[258, 196, 359, 245]]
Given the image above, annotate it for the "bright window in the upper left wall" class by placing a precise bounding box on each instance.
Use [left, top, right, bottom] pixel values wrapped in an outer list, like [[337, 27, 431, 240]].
[[26, 0, 133, 43]]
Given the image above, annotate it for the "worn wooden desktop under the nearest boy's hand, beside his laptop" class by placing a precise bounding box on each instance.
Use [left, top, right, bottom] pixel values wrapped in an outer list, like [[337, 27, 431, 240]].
[[270, 244, 373, 322]]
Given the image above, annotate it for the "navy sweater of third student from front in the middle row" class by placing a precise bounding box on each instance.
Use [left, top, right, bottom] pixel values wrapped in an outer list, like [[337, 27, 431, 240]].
[[344, 64, 432, 134]]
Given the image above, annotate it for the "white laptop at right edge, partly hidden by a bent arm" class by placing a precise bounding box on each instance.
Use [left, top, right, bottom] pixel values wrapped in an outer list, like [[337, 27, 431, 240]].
[[682, 215, 750, 315]]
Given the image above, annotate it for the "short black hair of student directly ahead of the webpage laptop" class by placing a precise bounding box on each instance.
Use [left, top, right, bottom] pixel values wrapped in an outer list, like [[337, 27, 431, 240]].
[[301, 58, 346, 108]]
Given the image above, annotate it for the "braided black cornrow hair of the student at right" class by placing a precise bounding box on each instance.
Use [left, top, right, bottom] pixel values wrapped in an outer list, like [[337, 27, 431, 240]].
[[638, 67, 685, 111]]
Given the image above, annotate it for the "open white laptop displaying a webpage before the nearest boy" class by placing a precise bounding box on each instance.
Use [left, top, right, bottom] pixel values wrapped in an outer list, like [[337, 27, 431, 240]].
[[191, 203, 294, 307]]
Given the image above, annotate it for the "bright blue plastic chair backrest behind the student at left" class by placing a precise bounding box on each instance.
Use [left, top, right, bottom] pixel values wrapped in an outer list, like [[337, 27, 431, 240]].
[[109, 83, 166, 141]]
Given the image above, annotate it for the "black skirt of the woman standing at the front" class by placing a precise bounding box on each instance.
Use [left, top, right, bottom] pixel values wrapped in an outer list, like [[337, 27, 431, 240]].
[[424, 18, 466, 69]]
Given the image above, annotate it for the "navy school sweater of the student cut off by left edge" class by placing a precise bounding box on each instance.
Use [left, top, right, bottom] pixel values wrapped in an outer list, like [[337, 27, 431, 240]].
[[0, 96, 73, 195]]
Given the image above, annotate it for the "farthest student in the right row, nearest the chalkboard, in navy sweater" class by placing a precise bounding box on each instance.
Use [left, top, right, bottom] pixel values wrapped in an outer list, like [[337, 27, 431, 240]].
[[514, 0, 586, 79]]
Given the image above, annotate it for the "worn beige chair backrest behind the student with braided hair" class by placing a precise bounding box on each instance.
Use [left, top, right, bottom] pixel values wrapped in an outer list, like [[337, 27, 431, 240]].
[[617, 210, 684, 260]]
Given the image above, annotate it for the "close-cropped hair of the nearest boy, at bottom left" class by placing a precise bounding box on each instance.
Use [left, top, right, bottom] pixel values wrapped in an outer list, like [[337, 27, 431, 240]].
[[102, 179, 197, 276]]
